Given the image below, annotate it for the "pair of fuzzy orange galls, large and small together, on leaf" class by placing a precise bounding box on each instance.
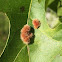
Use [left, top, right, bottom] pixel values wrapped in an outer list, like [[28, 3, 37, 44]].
[[20, 19, 40, 44]]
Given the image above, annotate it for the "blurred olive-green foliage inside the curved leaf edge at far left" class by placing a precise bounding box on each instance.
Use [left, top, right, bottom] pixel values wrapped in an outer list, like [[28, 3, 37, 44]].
[[0, 12, 9, 53]]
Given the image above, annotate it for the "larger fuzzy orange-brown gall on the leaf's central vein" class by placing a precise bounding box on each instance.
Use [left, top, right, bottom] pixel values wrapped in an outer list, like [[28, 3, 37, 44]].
[[20, 25, 33, 44]]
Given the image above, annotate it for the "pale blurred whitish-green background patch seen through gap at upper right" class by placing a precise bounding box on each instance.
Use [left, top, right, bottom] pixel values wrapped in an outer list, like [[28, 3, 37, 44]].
[[46, 8, 60, 28]]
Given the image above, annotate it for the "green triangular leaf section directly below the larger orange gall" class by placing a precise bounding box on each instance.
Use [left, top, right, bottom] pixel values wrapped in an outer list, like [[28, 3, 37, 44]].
[[14, 45, 29, 62]]
